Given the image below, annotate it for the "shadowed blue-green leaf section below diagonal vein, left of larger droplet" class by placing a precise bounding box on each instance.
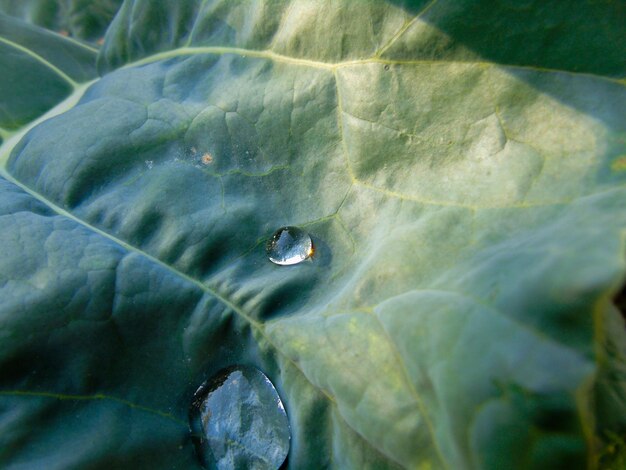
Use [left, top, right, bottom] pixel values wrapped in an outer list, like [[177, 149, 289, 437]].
[[0, 179, 272, 469]]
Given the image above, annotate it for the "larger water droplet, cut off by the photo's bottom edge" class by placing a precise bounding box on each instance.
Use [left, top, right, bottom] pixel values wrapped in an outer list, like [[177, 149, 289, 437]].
[[189, 366, 291, 470]]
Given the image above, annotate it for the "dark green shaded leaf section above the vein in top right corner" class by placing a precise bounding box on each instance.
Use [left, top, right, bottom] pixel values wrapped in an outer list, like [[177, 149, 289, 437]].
[[384, 0, 626, 77]]
